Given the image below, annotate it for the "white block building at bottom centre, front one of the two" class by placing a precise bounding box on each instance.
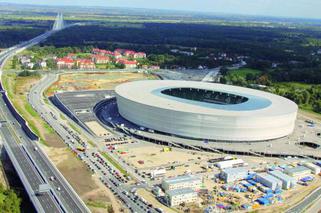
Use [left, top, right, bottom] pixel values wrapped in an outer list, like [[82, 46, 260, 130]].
[[166, 188, 198, 206]]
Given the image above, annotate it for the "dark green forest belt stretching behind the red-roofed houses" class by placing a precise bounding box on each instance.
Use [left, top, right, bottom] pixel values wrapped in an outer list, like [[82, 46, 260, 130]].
[[42, 23, 321, 84]]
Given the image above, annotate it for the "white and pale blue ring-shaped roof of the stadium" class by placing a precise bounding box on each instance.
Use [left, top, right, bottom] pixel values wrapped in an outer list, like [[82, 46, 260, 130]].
[[116, 80, 298, 117]]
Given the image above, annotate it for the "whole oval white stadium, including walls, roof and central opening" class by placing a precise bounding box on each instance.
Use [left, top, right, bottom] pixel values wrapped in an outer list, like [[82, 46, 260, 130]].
[[115, 80, 298, 141]]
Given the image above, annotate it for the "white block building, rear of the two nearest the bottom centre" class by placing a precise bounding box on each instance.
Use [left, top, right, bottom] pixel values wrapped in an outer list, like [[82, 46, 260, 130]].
[[162, 175, 202, 191]]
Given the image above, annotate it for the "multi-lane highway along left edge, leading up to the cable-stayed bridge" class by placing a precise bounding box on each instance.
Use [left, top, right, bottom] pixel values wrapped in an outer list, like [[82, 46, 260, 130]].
[[0, 14, 89, 213]]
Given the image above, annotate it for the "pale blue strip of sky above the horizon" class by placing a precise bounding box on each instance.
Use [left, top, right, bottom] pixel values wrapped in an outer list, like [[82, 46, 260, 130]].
[[0, 0, 321, 18]]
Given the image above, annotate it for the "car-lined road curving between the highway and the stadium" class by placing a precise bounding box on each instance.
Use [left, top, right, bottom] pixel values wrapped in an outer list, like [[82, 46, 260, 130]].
[[28, 73, 156, 212]]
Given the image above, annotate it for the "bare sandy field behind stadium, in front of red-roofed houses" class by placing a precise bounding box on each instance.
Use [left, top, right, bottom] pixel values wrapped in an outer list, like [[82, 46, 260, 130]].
[[46, 72, 158, 96]]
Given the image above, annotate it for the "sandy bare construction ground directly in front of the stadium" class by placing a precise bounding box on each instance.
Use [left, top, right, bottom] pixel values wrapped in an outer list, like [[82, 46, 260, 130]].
[[117, 143, 282, 177]]
